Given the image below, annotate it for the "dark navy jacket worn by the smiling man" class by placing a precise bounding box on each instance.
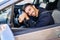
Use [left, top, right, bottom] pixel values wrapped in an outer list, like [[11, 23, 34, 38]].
[[23, 8, 54, 28]]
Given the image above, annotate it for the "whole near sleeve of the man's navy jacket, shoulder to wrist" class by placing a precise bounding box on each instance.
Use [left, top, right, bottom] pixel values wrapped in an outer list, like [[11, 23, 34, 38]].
[[23, 13, 53, 28]]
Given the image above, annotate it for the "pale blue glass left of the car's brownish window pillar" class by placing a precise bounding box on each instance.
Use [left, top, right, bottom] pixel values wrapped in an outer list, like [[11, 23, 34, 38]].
[[0, 9, 11, 24]]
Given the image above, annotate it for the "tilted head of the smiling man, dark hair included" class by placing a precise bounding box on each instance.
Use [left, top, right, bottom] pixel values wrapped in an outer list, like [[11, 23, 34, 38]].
[[22, 3, 37, 16]]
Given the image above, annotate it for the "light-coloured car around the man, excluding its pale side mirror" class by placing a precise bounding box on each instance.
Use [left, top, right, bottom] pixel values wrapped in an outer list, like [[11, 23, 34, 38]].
[[0, 0, 60, 40]]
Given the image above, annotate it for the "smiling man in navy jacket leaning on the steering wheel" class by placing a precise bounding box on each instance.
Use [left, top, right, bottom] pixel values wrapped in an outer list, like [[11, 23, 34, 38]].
[[18, 3, 54, 28]]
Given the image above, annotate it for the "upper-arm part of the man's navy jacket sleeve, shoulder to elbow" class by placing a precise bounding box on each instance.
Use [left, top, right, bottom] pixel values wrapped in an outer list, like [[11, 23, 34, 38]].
[[33, 13, 53, 27]]
